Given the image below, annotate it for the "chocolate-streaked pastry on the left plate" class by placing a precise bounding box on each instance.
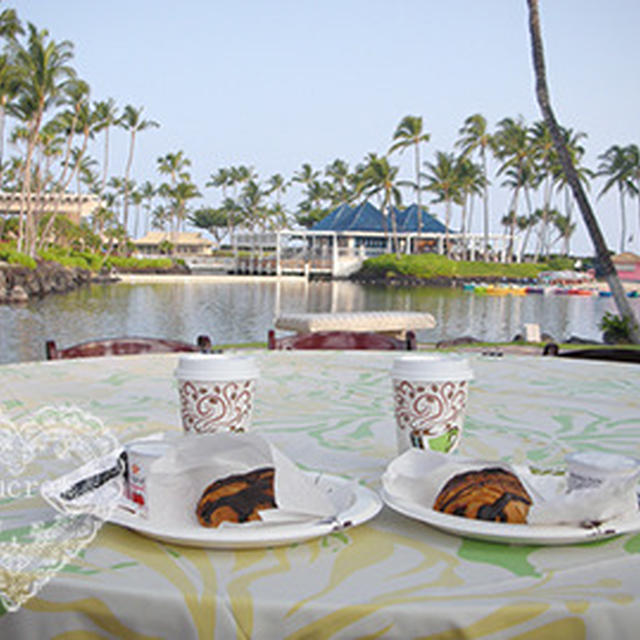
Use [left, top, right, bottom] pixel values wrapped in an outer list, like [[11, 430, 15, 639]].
[[196, 467, 277, 527]]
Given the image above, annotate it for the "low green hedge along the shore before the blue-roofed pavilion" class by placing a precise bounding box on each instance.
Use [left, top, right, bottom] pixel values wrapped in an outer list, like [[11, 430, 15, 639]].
[[361, 253, 547, 278]]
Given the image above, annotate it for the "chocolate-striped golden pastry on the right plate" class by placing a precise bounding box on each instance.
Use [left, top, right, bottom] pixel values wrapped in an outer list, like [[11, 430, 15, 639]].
[[433, 467, 531, 524]]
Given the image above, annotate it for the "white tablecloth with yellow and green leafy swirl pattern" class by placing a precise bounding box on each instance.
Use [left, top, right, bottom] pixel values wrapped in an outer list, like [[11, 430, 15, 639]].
[[0, 351, 640, 640]]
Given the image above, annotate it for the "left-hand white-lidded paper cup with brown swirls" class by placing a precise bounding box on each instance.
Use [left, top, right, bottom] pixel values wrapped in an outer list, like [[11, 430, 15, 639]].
[[175, 353, 259, 434]]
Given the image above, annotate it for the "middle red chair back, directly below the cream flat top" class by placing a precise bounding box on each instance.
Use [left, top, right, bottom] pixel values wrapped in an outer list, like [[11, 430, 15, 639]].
[[267, 329, 417, 351]]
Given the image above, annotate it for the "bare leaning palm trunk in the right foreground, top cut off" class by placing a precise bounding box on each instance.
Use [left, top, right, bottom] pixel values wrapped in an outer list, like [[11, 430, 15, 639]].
[[527, 0, 640, 343]]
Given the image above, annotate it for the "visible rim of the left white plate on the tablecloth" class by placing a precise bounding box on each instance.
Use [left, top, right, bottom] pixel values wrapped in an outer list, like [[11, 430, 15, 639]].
[[109, 474, 382, 549]]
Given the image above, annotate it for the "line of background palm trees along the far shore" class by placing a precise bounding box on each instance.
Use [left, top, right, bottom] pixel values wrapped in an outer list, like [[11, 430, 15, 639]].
[[0, 9, 640, 259]]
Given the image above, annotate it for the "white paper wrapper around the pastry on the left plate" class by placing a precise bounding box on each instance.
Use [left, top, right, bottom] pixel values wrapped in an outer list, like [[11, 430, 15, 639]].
[[142, 433, 336, 527]]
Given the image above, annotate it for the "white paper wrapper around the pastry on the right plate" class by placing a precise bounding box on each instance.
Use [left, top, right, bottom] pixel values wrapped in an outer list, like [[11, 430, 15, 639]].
[[382, 449, 638, 526]]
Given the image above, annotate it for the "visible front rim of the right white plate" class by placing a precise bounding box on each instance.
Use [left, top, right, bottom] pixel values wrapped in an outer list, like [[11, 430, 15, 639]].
[[382, 489, 640, 545]]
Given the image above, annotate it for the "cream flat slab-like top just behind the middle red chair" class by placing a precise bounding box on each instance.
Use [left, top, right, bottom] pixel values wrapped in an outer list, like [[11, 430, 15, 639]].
[[274, 311, 436, 340]]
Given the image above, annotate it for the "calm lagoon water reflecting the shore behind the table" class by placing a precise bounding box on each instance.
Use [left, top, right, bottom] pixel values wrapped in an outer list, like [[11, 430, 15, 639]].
[[0, 278, 640, 363]]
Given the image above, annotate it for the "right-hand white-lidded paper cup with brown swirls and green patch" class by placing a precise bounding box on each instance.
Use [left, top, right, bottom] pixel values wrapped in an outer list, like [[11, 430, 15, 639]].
[[391, 354, 473, 453]]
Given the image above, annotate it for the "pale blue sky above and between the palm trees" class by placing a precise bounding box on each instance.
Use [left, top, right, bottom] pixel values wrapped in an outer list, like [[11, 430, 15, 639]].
[[4, 0, 640, 253]]
